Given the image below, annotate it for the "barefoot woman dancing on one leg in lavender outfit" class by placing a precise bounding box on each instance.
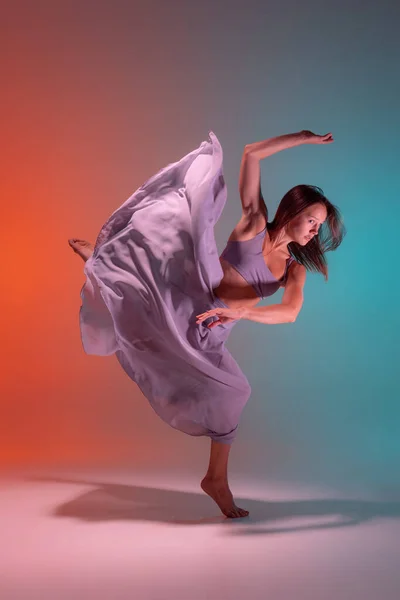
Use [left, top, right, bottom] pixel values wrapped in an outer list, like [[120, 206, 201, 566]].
[[69, 131, 345, 518]]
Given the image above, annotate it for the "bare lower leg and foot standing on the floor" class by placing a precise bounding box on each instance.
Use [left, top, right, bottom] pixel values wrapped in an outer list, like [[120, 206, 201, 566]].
[[201, 440, 249, 519]]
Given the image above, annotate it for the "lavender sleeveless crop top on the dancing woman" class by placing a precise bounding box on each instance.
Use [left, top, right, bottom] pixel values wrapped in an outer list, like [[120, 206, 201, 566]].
[[221, 227, 294, 298]]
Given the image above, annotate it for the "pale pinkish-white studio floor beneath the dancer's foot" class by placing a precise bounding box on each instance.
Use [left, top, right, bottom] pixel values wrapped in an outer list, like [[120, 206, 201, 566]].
[[0, 470, 400, 600]]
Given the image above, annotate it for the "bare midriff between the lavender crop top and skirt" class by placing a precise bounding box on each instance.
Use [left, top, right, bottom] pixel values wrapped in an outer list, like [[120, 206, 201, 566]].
[[213, 258, 261, 308]]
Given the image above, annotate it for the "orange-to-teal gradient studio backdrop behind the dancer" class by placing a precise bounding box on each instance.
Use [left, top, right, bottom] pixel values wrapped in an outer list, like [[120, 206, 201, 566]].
[[0, 0, 400, 489]]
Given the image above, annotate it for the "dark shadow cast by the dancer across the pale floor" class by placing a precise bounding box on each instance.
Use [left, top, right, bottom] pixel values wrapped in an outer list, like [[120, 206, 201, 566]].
[[29, 477, 400, 535]]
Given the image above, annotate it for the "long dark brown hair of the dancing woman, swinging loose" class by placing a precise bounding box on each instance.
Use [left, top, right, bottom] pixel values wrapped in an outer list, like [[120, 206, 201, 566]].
[[267, 185, 346, 281]]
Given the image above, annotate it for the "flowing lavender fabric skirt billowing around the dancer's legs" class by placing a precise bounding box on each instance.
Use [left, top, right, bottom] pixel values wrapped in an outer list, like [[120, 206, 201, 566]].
[[79, 132, 251, 444]]
